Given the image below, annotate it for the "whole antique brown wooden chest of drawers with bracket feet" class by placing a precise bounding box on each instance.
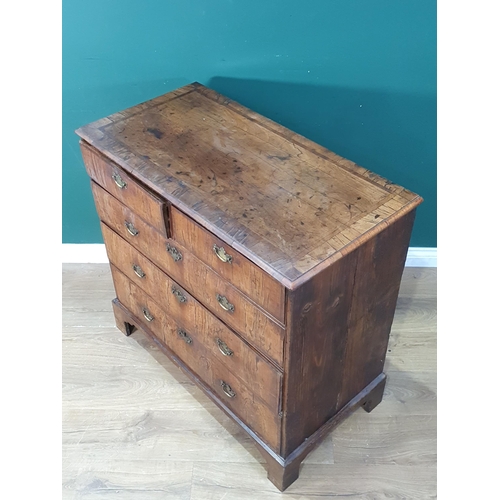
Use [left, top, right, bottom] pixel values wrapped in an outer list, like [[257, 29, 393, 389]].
[[77, 83, 422, 490]]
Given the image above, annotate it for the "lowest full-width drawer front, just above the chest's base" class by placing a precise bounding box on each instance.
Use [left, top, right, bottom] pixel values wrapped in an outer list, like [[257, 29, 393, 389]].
[[111, 265, 281, 453]]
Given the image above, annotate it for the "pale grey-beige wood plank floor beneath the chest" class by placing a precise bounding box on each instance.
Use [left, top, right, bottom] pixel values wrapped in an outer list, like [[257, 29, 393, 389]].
[[62, 264, 437, 500]]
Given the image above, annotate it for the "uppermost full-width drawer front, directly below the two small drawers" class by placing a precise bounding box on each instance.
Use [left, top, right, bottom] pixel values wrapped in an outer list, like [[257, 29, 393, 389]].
[[92, 183, 285, 366]]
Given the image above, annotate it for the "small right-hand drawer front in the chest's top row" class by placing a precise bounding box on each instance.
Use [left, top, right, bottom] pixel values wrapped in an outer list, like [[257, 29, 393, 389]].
[[170, 207, 285, 324]]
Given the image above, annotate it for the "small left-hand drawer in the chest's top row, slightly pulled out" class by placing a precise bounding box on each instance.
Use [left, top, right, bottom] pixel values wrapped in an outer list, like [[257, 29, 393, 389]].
[[81, 143, 168, 236]]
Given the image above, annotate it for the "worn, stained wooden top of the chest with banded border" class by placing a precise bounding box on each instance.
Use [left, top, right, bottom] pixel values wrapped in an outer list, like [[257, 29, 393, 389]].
[[77, 83, 422, 289]]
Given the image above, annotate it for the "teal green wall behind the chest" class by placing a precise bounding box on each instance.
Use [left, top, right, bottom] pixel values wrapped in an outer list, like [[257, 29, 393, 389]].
[[62, 0, 437, 247]]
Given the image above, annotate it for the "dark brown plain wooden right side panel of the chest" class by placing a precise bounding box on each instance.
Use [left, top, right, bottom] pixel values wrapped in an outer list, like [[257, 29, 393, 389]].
[[281, 211, 415, 457]]
